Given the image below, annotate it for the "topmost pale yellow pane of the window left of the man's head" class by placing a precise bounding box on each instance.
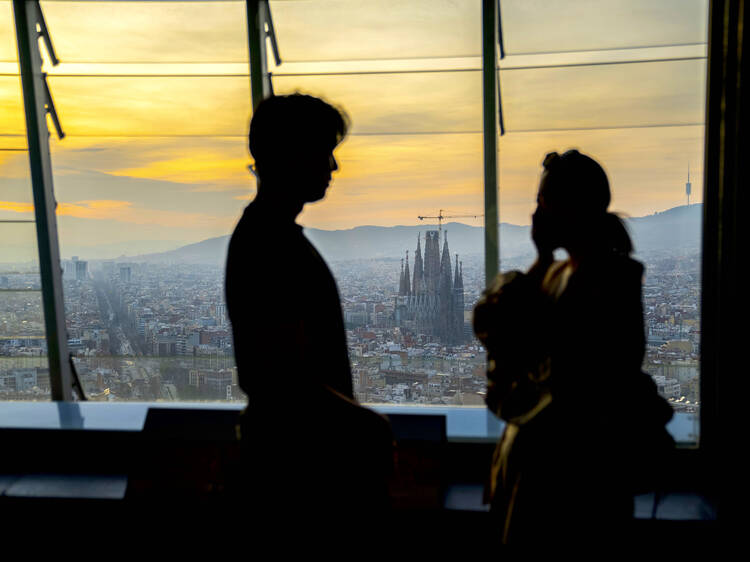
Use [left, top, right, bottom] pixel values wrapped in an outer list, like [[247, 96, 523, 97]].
[[42, 0, 248, 63]]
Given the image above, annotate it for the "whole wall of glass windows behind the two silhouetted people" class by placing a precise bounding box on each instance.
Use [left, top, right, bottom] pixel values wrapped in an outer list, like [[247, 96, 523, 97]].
[[5, 0, 708, 439]]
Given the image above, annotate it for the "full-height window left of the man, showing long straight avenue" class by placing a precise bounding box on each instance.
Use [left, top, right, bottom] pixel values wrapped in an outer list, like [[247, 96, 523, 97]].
[[37, 1, 254, 404]]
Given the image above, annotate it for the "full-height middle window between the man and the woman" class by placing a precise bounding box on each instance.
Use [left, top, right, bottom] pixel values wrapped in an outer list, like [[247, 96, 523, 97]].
[[272, 2, 486, 408]]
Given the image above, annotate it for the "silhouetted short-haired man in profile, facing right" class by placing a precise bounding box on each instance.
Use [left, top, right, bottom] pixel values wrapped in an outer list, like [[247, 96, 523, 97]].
[[226, 94, 393, 526]]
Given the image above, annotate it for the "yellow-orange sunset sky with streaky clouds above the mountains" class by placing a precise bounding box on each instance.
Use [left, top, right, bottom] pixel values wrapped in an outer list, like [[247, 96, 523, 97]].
[[0, 0, 707, 262]]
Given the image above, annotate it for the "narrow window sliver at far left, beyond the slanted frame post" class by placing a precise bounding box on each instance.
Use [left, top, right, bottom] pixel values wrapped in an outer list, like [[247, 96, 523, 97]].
[[0, 2, 50, 401]]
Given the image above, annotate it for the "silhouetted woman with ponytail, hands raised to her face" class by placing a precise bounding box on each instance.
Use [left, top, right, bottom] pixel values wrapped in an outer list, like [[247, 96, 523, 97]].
[[474, 150, 674, 546]]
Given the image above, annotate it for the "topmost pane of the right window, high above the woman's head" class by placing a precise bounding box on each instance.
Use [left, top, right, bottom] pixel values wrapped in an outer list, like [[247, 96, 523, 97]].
[[500, 0, 708, 54]]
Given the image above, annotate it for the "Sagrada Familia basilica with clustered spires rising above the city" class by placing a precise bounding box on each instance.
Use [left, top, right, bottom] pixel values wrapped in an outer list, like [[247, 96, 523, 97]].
[[393, 230, 465, 345]]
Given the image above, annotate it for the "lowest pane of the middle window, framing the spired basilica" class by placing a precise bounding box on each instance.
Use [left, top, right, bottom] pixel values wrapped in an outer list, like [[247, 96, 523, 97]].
[[300, 133, 486, 407]]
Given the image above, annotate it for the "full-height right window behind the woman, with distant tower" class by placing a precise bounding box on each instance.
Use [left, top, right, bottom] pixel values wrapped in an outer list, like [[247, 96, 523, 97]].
[[499, 0, 708, 443]]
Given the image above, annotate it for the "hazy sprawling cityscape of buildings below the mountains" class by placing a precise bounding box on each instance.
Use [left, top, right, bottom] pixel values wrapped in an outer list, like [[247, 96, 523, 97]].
[[0, 207, 701, 413]]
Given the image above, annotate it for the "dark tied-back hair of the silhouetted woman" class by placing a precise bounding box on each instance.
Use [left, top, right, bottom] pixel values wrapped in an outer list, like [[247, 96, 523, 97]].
[[542, 150, 633, 254]]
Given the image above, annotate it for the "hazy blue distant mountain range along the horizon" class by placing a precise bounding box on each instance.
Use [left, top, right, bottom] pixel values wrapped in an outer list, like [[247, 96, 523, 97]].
[[113, 204, 703, 265]]
